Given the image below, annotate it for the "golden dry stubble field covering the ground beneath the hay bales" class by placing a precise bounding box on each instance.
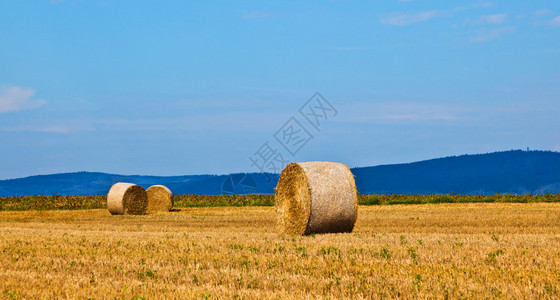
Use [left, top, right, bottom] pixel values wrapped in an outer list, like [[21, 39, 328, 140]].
[[0, 203, 560, 299]]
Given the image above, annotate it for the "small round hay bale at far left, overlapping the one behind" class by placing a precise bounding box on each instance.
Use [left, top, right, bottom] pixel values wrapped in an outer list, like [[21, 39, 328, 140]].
[[107, 182, 148, 215]]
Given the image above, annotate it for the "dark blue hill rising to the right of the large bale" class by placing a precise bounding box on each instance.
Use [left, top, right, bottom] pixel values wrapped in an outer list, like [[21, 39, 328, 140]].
[[352, 150, 560, 194]]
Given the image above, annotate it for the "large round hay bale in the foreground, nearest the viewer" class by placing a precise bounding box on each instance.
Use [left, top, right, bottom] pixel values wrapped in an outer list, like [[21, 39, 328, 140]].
[[274, 162, 358, 235]]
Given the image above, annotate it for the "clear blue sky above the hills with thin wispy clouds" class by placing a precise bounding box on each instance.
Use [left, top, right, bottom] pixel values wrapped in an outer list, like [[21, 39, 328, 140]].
[[0, 0, 560, 179]]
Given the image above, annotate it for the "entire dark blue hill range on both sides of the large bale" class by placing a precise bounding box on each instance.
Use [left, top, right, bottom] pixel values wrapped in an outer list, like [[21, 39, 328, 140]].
[[0, 150, 560, 196]]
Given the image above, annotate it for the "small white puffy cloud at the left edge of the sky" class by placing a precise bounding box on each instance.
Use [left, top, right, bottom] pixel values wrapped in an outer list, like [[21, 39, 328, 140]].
[[0, 85, 47, 113]]
